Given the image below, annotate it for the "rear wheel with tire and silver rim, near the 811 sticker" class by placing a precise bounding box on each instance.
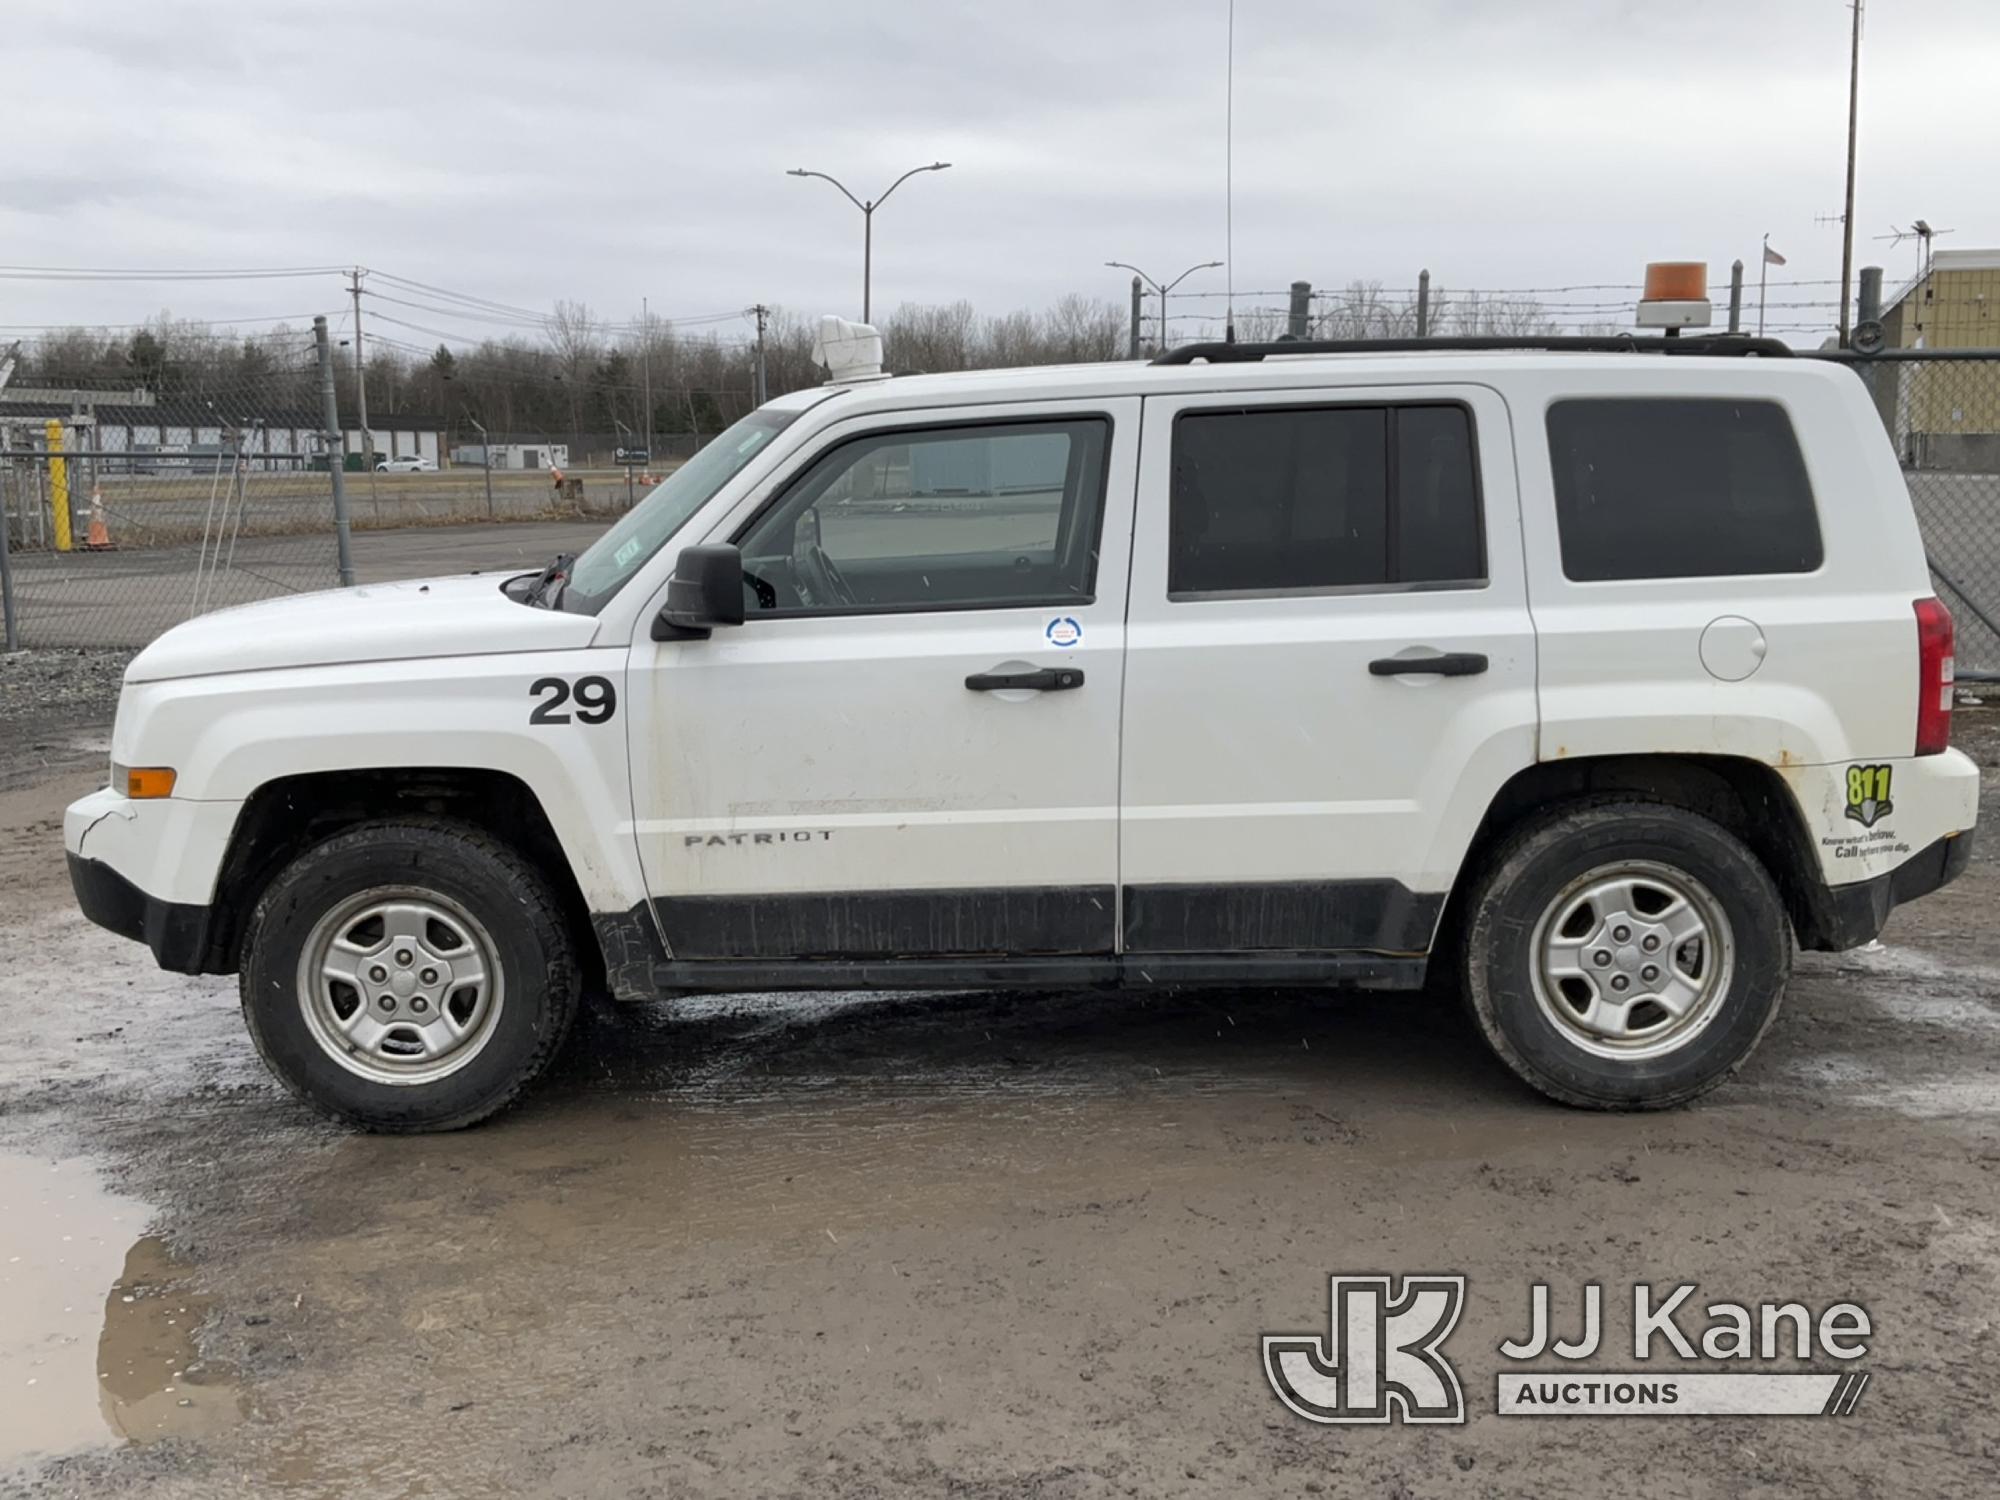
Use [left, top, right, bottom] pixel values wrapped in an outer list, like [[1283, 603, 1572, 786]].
[[1464, 802, 1792, 1110]]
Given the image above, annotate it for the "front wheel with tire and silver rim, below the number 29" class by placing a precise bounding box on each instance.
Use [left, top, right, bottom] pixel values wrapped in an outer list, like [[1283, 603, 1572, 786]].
[[240, 822, 578, 1132]]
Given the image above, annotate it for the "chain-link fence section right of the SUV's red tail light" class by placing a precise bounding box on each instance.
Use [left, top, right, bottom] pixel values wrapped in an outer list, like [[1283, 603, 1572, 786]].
[[1842, 350, 2000, 678]]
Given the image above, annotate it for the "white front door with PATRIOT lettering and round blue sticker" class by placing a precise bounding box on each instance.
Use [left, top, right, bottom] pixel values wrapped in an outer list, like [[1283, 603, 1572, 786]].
[[628, 398, 1140, 962]]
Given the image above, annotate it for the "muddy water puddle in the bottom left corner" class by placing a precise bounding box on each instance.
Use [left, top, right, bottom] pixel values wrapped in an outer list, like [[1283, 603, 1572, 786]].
[[0, 1152, 242, 1466]]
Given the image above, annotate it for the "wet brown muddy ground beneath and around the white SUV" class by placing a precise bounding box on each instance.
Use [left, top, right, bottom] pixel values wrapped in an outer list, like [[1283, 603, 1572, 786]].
[[0, 714, 2000, 1498]]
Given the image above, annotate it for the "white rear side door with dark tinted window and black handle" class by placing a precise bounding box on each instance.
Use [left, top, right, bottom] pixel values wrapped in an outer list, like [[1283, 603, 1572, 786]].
[[1120, 386, 1536, 954]]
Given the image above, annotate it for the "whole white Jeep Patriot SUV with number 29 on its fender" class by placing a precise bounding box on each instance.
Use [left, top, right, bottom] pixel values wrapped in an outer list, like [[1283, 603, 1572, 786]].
[[64, 324, 1978, 1130]]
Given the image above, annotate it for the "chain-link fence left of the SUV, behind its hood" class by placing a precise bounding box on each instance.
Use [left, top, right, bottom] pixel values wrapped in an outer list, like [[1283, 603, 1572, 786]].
[[0, 368, 656, 648]]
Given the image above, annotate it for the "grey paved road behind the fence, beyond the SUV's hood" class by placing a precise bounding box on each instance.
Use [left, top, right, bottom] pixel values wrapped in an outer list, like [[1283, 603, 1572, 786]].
[[14, 520, 610, 646]]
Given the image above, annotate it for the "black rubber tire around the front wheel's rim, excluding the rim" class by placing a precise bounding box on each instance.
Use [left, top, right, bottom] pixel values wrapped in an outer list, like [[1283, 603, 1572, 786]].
[[238, 820, 580, 1132]]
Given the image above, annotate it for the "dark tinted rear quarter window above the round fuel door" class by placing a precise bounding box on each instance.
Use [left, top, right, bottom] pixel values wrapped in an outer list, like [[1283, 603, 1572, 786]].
[[1548, 398, 1824, 582]]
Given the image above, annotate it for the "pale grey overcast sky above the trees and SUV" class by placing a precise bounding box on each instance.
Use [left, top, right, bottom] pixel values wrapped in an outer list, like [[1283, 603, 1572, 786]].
[[0, 0, 2000, 344]]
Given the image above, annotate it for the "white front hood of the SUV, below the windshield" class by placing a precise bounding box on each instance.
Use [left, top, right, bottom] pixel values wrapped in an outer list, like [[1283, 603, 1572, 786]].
[[126, 574, 598, 682]]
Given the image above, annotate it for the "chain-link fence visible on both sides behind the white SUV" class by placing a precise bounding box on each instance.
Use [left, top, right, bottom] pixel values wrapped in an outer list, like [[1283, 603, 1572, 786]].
[[15, 350, 2000, 676]]
